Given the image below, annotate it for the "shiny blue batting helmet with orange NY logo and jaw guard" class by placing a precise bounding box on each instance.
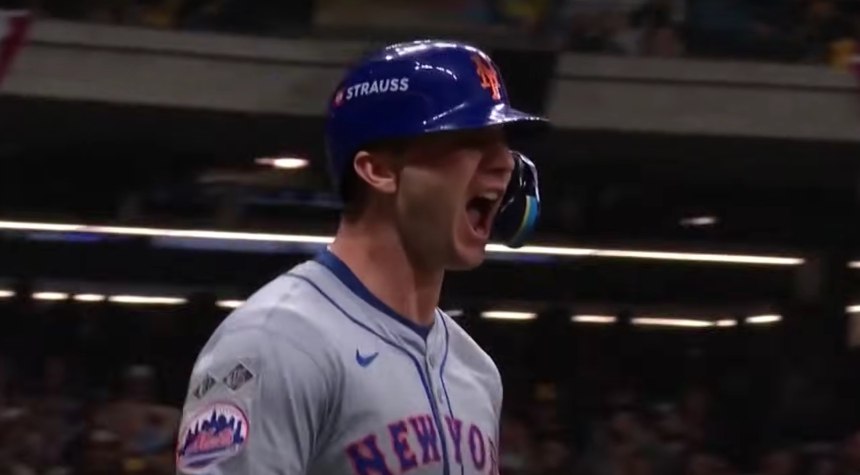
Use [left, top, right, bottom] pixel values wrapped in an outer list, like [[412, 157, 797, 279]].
[[325, 40, 546, 246]]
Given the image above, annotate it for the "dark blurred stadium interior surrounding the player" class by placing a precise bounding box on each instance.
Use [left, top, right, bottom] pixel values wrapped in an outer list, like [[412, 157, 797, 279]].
[[8, 0, 860, 475]]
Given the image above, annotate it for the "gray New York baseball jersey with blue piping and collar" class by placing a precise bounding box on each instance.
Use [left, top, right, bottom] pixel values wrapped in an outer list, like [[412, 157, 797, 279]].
[[177, 252, 502, 475]]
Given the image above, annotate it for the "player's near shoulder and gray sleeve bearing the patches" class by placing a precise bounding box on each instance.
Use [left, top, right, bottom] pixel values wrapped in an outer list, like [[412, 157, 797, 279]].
[[177, 262, 344, 475]]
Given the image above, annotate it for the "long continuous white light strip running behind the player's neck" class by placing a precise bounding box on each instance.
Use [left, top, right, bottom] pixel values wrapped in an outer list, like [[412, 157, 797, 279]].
[[0, 221, 804, 266]]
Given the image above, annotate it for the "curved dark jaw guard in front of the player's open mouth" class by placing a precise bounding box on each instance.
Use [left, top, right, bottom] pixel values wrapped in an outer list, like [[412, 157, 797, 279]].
[[493, 150, 540, 248]]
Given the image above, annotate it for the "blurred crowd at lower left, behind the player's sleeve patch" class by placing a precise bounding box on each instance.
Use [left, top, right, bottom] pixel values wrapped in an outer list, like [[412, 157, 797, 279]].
[[0, 357, 180, 475]]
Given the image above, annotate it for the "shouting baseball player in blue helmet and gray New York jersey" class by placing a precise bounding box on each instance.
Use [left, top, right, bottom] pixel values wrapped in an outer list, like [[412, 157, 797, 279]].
[[176, 40, 544, 475]]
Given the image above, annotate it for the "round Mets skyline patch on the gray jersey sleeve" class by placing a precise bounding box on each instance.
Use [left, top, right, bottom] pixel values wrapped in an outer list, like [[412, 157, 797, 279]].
[[176, 402, 248, 473]]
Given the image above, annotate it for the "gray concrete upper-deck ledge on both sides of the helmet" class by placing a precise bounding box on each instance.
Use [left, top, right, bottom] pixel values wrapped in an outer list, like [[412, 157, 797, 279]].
[[4, 20, 860, 142]]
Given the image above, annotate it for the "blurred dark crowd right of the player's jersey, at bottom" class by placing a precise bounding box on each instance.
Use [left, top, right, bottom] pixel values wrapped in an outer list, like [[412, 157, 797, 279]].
[[501, 386, 860, 475]]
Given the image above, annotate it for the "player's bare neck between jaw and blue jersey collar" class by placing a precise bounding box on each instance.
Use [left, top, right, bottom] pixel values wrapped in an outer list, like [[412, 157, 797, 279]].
[[330, 216, 445, 326]]
